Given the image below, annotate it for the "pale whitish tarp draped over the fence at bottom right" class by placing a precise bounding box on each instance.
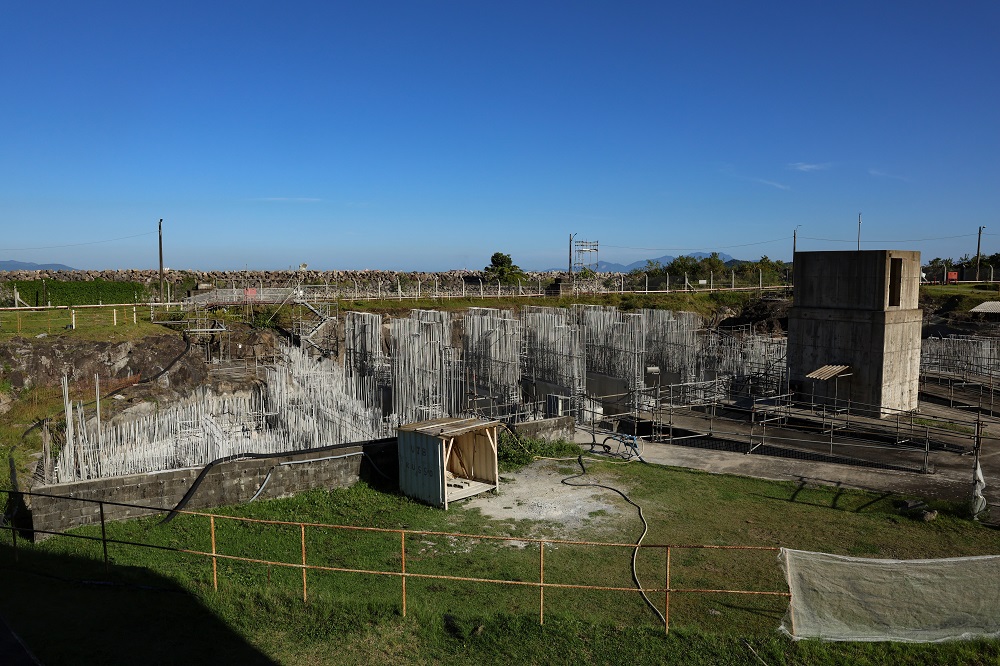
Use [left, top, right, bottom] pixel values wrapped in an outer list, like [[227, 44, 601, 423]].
[[778, 548, 1000, 642]]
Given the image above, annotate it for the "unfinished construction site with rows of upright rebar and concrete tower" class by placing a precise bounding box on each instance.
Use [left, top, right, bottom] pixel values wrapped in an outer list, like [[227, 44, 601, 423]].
[[27, 251, 997, 528]]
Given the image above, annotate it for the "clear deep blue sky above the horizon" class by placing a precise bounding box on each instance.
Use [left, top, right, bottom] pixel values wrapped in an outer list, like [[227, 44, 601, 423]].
[[0, 0, 1000, 270]]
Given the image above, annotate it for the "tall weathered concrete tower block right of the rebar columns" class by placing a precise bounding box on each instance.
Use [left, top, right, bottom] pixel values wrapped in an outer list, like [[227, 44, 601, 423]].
[[788, 250, 923, 416]]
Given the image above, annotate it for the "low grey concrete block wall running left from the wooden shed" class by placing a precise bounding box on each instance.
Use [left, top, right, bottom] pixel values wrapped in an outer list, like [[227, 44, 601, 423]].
[[26, 439, 398, 539]]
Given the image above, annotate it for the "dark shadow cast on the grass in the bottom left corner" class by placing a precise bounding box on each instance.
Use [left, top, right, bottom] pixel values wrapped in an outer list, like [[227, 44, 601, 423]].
[[0, 544, 275, 666]]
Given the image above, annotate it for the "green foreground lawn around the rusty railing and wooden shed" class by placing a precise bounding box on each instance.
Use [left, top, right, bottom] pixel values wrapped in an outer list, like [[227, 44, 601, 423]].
[[0, 461, 1000, 664]]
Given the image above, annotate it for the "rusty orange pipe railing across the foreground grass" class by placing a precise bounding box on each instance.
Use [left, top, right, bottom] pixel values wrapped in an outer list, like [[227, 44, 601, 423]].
[[0, 490, 791, 632]]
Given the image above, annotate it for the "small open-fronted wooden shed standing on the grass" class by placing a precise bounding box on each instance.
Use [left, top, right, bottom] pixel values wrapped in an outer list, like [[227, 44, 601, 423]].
[[396, 418, 500, 509]]
